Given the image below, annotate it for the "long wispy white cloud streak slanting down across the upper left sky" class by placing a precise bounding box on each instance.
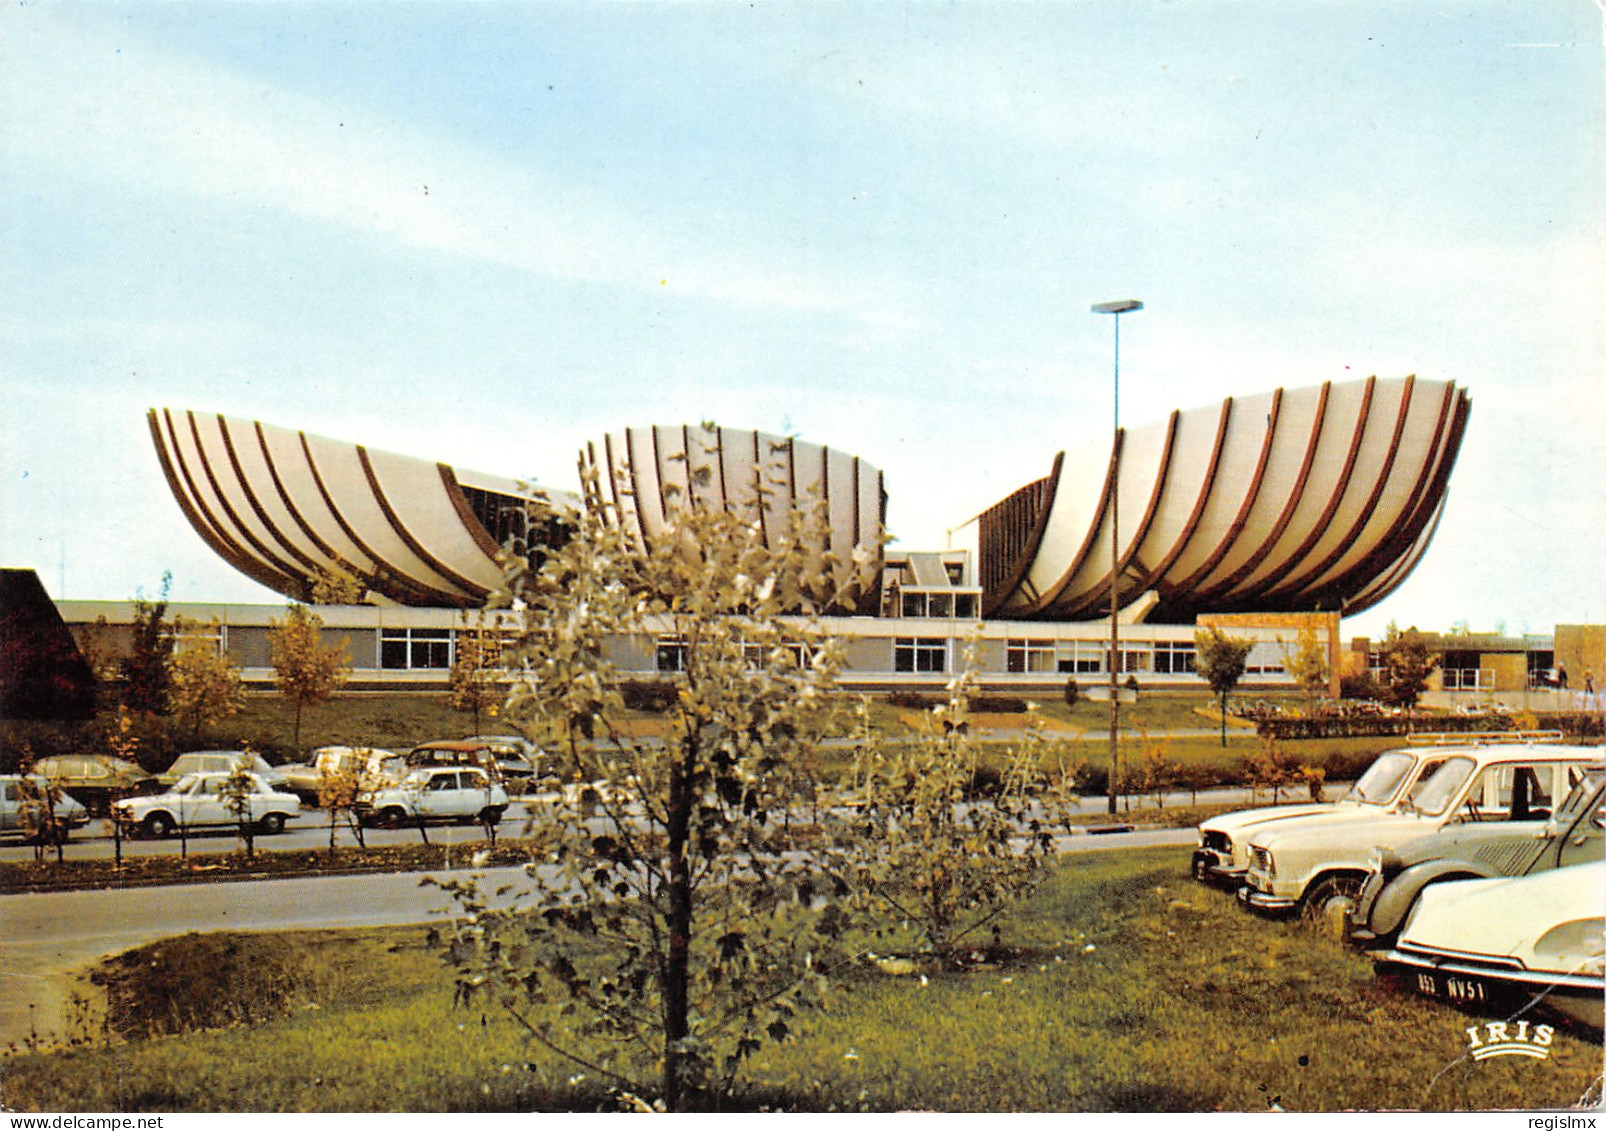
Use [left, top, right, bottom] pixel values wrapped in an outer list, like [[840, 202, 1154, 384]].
[[0, 8, 909, 334]]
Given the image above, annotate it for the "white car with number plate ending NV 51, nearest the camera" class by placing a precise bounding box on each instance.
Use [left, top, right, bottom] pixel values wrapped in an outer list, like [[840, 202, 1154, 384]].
[[1373, 861, 1606, 1030]]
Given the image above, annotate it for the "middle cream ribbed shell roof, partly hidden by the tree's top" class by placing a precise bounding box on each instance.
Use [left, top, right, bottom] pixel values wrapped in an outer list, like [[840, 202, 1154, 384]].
[[586, 424, 887, 614]]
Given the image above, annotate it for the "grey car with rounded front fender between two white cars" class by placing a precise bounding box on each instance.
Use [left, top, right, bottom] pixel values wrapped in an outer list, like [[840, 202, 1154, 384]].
[[1351, 765, 1606, 948]]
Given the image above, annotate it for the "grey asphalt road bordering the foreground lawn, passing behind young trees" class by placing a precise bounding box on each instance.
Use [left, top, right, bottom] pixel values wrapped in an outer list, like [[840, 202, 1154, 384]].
[[0, 829, 1196, 1046]]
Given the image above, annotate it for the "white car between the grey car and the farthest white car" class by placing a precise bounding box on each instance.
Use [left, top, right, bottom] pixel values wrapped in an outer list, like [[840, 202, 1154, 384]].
[[1238, 742, 1601, 922]]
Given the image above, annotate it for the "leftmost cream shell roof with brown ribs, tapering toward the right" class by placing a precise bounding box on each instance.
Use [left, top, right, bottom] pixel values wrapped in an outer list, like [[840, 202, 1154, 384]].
[[148, 408, 575, 607]]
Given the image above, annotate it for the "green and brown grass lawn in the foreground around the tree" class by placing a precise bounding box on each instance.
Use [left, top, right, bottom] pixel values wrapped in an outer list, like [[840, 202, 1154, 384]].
[[0, 848, 1601, 1112]]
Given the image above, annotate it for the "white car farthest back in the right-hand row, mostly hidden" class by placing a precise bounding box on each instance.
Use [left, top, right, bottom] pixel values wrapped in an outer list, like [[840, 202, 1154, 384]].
[[1193, 736, 1477, 892]]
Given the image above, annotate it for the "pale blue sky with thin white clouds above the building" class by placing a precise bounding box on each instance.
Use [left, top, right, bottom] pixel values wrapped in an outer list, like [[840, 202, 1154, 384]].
[[0, 0, 1606, 635]]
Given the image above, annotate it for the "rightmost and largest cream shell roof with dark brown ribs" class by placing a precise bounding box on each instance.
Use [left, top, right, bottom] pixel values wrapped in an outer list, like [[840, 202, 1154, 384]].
[[980, 378, 1471, 623]]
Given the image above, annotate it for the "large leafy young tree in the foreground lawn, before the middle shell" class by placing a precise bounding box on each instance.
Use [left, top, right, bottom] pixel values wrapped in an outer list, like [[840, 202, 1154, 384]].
[[433, 449, 875, 1110]]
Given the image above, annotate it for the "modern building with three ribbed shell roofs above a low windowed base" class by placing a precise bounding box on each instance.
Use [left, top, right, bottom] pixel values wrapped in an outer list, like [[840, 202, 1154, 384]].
[[50, 378, 1471, 694]]
